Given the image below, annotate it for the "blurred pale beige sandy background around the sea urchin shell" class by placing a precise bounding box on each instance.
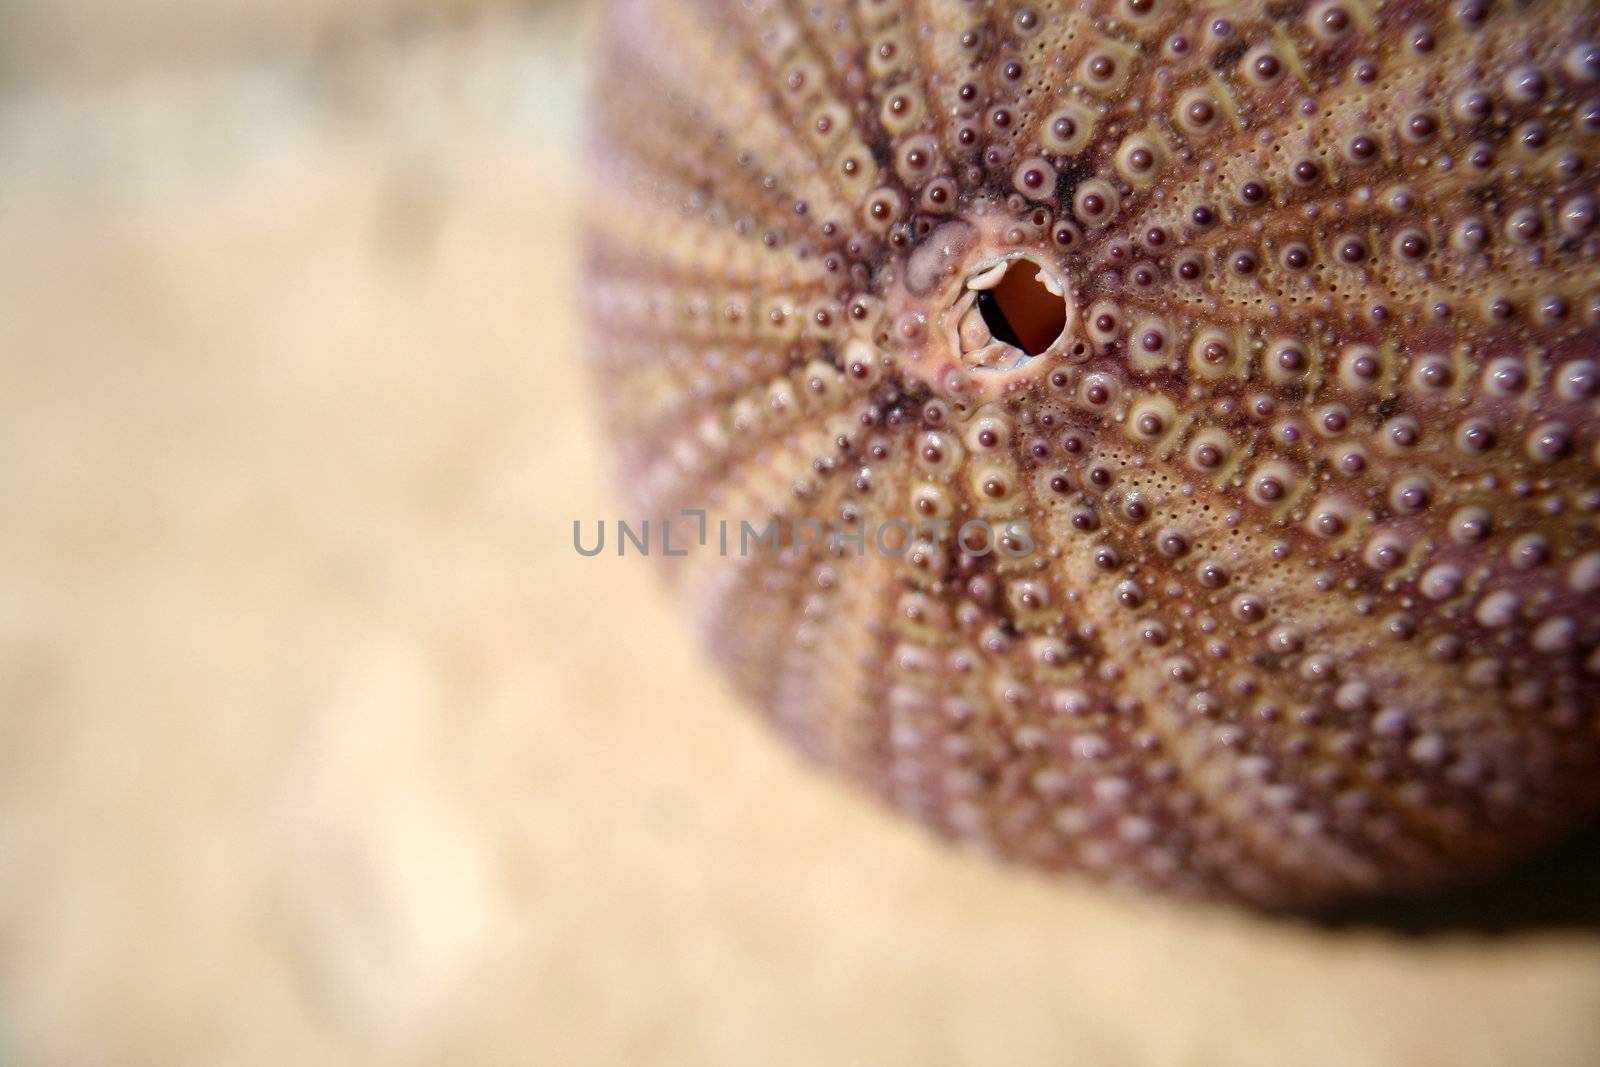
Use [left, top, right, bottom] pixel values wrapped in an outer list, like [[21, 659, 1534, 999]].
[[0, 0, 1600, 1067]]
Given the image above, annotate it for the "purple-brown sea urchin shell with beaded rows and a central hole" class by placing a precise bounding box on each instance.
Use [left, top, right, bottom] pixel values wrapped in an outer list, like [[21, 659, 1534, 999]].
[[582, 0, 1600, 905]]
